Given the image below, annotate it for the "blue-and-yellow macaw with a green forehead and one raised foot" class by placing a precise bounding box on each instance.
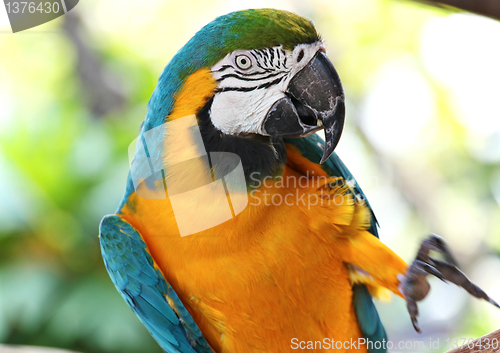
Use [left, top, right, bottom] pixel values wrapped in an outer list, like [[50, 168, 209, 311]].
[[100, 9, 498, 353]]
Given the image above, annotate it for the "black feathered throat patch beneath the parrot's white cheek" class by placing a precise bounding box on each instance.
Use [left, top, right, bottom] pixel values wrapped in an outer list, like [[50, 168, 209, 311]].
[[196, 98, 286, 187]]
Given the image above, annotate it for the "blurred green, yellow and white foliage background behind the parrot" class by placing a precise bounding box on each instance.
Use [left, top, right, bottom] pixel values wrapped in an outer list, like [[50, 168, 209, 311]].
[[0, 0, 500, 353]]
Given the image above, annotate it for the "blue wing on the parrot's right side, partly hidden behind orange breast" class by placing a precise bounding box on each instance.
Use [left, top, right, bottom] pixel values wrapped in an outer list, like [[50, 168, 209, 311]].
[[285, 134, 387, 353]]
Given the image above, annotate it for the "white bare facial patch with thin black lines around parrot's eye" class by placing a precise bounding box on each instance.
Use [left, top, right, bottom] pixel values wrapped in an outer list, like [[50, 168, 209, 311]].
[[210, 41, 325, 135]]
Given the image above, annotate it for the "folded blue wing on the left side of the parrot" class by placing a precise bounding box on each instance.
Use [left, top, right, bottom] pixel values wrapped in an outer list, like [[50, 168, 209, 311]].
[[99, 215, 212, 353]]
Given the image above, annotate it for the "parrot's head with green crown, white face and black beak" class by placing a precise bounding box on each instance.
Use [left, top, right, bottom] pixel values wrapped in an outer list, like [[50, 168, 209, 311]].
[[143, 9, 345, 179]]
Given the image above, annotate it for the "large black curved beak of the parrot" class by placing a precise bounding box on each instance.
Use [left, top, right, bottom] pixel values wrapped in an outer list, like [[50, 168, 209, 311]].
[[262, 51, 345, 163]]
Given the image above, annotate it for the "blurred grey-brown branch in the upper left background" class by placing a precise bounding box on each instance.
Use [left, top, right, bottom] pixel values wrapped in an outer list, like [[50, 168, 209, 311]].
[[63, 10, 125, 117]]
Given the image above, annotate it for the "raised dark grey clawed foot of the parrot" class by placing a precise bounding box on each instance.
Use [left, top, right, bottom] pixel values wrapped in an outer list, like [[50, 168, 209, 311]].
[[399, 234, 500, 332]]
